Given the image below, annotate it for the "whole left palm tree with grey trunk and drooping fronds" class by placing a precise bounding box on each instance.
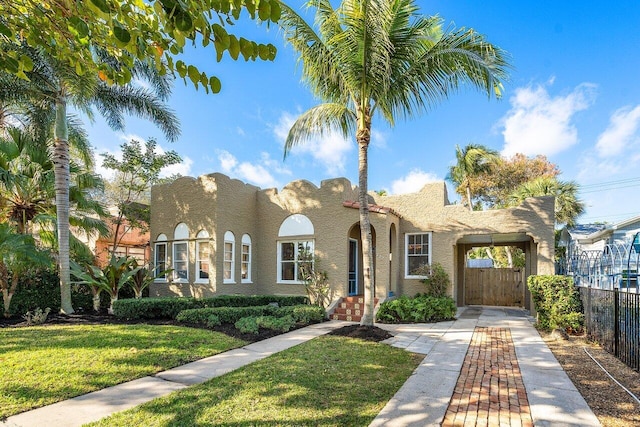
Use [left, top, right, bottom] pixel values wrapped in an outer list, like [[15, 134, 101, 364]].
[[0, 45, 179, 314]]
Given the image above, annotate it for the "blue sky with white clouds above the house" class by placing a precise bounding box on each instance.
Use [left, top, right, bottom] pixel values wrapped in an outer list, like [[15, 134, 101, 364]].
[[88, 0, 640, 223]]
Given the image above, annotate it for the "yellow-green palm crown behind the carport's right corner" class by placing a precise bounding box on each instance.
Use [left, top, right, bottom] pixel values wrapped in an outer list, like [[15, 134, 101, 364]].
[[509, 177, 585, 227]]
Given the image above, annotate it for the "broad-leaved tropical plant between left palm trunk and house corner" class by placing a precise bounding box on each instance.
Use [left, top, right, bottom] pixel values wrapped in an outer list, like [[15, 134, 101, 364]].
[[71, 256, 141, 314]]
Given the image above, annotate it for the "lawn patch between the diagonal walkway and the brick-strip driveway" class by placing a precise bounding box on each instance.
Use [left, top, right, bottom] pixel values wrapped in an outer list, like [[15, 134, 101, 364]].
[[86, 336, 423, 427]]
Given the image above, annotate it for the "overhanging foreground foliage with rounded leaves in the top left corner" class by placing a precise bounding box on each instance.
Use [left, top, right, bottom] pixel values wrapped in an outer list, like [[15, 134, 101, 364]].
[[0, 0, 280, 92]]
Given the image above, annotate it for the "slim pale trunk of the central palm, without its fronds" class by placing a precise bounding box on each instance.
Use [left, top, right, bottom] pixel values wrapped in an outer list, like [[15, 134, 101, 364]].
[[356, 116, 375, 326]]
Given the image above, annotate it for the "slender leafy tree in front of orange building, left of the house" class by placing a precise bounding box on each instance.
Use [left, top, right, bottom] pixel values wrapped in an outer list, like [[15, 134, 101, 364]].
[[102, 139, 182, 253]]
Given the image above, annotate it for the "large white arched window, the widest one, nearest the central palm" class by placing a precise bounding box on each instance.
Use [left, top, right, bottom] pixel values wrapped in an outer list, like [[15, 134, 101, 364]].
[[278, 214, 314, 284]]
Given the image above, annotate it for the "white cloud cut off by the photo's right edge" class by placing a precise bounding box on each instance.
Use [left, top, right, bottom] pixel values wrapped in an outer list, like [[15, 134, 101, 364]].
[[596, 105, 640, 157]]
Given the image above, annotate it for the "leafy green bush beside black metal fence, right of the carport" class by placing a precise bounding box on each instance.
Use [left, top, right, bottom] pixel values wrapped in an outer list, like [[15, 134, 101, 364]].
[[527, 276, 584, 332]]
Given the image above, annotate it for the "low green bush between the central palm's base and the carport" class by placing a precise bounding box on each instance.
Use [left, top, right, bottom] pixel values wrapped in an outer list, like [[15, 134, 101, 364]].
[[376, 295, 457, 323]]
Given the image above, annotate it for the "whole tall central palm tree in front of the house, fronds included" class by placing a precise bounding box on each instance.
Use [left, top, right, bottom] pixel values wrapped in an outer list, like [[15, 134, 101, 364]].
[[279, 0, 508, 326]]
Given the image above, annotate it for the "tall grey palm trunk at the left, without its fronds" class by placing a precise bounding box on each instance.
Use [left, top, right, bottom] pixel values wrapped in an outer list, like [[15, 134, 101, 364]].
[[52, 98, 74, 314]]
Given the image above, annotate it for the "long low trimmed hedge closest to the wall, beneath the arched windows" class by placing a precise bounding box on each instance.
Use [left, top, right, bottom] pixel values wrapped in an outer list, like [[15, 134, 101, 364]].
[[113, 295, 308, 319]]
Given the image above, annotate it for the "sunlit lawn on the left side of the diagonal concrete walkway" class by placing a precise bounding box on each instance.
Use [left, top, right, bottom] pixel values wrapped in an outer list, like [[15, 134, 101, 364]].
[[0, 324, 245, 420]]
